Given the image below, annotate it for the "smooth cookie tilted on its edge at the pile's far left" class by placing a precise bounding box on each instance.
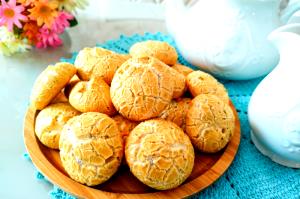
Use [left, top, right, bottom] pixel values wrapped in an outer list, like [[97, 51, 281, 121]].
[[30, 63, 76, 110]]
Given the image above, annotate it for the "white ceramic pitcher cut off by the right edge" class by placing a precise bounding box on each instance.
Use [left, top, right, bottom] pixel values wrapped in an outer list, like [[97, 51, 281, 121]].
[[248, 24, 300, 168]]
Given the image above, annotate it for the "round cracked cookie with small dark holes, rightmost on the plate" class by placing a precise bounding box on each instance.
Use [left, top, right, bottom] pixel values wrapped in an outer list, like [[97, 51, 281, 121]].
[[186, 94, 235, 153]]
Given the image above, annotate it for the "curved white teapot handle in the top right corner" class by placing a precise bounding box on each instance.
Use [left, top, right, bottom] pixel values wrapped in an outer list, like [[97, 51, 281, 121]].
[[281, 0, 300, 24]]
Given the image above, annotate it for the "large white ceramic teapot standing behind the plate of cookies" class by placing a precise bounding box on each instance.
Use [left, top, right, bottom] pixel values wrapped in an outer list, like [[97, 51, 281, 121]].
[[166, 0, 300, 80]]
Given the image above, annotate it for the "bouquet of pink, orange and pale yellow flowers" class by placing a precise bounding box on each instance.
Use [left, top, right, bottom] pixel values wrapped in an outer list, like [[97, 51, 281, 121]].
[[0, 0, 87, 56]]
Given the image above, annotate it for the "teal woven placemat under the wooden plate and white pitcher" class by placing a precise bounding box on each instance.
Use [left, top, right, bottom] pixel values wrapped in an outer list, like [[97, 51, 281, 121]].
[[24, 33, 300, 199]]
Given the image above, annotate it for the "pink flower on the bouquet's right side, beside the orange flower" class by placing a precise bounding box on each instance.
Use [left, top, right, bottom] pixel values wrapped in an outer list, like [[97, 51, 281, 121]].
[[51, 11, 74, 34]]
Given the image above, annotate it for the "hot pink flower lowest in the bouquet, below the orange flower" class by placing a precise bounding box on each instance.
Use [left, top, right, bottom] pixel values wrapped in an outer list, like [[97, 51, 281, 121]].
[[36, 26, 62, 48]]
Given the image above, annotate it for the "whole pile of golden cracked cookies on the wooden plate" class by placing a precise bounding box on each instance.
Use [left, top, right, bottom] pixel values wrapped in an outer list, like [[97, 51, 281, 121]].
[[31, 41, 235, 190]]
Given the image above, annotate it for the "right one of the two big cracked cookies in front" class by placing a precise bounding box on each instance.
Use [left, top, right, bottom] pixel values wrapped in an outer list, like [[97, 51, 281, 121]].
[[125, 120, 195, 190]]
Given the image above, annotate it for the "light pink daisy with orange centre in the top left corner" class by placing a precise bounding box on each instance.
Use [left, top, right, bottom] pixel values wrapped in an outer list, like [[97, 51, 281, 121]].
[[0, 0, 27, 31]]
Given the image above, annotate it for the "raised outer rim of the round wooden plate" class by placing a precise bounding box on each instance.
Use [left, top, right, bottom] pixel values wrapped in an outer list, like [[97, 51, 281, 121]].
[[23, 102, 240, 199]]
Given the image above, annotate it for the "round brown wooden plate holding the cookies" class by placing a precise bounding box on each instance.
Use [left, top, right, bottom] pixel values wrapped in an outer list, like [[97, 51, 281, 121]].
[[24, 103, 240, 199]]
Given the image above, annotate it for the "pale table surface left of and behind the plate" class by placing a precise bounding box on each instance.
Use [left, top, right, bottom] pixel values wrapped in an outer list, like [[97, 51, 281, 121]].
[[0, 2, 166, 199]]
